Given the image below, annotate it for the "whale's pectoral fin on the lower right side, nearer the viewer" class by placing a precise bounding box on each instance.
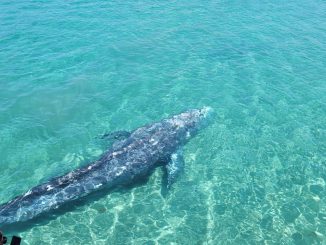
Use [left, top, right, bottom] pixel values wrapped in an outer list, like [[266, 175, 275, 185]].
[[166, 149, 185, 189]]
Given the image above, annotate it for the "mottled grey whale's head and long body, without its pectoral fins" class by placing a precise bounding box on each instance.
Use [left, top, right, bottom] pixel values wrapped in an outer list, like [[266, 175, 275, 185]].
[[0, 107, 211, 227]]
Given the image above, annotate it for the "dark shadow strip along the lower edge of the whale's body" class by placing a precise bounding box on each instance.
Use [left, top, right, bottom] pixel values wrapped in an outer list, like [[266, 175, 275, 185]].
[[1, 172, 155, 234]]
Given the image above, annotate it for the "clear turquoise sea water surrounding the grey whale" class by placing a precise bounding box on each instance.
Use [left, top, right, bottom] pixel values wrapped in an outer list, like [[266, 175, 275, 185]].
[[0, 0, 326, 244]]
